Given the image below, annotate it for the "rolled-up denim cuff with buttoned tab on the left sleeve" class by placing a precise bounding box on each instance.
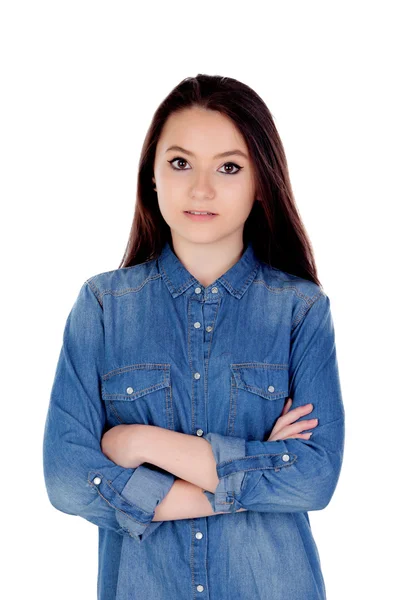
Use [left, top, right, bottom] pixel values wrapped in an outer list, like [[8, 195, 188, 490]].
[[91, 465, 176, 542]]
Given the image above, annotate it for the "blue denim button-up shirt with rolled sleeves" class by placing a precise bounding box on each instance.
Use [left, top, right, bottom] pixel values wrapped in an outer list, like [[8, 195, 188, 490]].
[[43, 243, 344, 600]]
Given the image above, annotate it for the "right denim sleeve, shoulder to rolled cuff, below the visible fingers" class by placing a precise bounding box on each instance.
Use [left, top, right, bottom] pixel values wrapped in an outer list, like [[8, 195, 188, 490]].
[[203, 290, 345, 512]]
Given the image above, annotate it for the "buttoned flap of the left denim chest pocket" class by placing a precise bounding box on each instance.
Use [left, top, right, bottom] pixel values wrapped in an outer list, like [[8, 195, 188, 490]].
[[102, 363, 171, 401]]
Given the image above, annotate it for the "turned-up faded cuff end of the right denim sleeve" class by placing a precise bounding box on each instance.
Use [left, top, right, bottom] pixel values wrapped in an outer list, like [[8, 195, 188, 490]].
[[203, 433, 246, 512]]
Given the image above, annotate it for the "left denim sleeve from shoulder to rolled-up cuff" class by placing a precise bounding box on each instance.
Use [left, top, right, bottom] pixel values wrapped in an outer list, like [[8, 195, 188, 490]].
[[43, 280, 176, 542]]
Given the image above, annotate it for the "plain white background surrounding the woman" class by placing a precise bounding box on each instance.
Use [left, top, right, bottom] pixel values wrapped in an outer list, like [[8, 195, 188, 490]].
[[0, 0, 400, 600]]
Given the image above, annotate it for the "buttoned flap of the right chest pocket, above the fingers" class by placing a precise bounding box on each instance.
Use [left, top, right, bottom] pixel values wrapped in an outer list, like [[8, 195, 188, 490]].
[[231, 363, 289, 400]]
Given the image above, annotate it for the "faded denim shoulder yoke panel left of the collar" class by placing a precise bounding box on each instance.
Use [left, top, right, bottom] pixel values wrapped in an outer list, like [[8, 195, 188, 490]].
[[83, 259, 160, 305]]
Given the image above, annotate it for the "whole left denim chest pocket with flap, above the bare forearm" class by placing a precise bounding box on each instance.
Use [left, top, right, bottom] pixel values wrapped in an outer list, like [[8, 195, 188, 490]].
[[102, 363, 174, 429]]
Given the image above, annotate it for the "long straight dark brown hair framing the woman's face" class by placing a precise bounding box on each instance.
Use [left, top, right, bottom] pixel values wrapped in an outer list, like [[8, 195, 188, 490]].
[[118, 74, 322, 287]]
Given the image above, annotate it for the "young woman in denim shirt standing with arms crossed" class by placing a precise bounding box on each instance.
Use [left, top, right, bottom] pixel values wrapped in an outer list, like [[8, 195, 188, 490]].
[[43, 75, 344, 600]]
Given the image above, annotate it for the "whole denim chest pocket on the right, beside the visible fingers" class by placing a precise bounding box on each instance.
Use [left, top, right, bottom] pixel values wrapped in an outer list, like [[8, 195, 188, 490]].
[[227, 362, 289, 441]]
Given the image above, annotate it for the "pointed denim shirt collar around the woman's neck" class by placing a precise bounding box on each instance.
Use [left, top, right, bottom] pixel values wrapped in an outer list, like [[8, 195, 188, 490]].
[[157, 241, 260, 298]]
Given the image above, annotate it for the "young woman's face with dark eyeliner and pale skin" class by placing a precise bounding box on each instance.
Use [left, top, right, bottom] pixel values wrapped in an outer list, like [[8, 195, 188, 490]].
[[153, 107, 255, 247]]
